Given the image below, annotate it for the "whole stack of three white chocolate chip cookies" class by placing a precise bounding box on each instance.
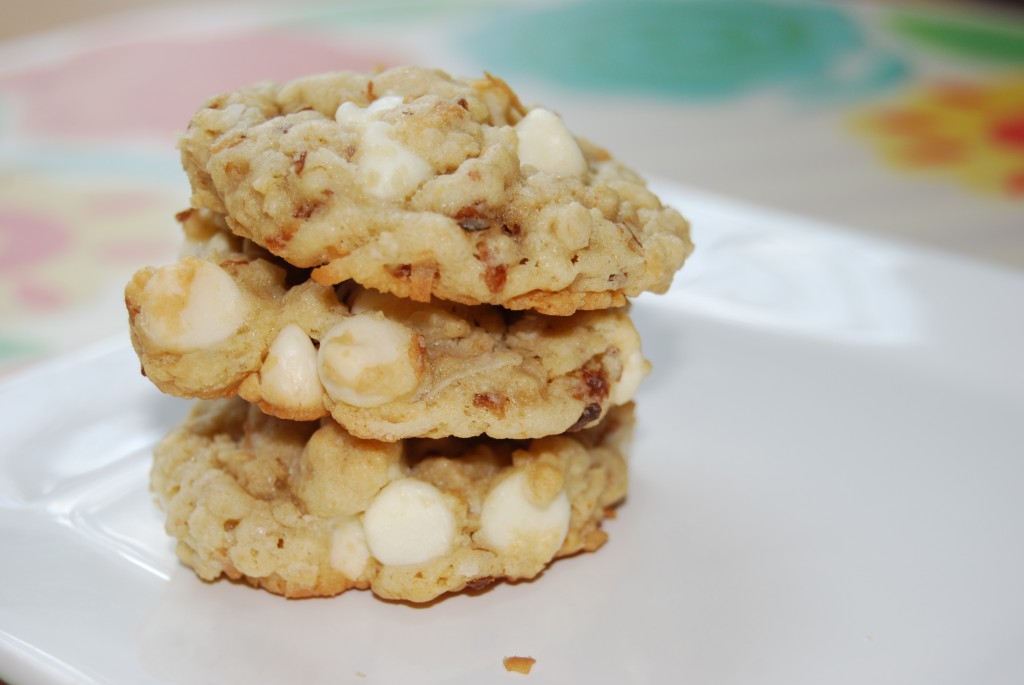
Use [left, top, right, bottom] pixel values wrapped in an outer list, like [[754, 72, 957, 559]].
[[125, 68, 692, 602]]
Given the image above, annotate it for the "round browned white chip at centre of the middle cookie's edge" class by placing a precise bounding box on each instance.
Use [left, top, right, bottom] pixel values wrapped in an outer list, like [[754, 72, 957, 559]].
[[317, 312, 423, 408]]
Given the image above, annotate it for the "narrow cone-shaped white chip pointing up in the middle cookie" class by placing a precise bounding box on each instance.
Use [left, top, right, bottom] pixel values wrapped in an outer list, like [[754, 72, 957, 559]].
[[260, 324, 324, 410]]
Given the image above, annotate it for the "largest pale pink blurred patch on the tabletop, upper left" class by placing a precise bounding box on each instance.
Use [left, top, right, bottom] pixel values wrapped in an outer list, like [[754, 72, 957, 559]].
[[0, 32, 395, 139]]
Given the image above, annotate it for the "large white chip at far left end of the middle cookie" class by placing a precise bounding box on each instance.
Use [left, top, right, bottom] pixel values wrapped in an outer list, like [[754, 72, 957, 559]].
[[136, 257, 247, 353]]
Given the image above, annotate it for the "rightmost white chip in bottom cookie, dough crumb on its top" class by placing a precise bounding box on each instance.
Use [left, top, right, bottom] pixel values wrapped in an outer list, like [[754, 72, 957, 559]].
[[475, 471, 571, 561]]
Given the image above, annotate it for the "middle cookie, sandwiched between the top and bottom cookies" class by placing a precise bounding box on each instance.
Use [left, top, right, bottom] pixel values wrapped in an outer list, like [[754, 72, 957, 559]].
[[125, 214, 649, 441]]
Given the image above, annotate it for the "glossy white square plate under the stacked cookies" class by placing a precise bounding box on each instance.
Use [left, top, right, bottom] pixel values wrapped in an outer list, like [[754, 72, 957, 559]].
[[0, 184, 1024, 685]]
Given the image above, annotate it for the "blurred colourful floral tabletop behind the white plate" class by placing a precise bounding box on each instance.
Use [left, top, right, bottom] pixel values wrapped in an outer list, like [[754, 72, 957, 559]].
[[0, 0, 1024, 375]]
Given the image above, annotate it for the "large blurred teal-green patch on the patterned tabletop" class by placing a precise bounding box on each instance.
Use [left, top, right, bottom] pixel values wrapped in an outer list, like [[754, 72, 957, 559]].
[[467, 0, 907, 99]]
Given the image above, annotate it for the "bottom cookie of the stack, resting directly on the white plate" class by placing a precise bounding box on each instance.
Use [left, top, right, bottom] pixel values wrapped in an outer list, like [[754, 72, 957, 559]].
[[152, 398, 633, 602]]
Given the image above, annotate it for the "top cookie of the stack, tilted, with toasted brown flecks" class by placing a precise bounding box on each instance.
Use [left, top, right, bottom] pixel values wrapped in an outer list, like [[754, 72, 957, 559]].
[[179, 63, 692, 315]]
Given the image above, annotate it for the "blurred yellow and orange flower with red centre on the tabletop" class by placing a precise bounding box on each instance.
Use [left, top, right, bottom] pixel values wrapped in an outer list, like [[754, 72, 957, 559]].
[[855, 79, 1024, 201]]
